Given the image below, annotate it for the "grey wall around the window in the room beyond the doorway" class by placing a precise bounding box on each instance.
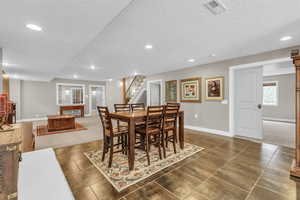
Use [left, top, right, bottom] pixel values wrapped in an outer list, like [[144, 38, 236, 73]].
[[263, 74, 295, 120]]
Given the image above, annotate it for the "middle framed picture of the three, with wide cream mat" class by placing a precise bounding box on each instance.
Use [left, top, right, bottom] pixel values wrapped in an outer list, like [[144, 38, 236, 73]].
[[180, 78, 201, 103]]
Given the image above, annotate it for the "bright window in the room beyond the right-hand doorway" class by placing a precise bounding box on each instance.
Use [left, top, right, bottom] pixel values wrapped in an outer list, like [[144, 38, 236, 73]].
[[263, 81, 278, 106]]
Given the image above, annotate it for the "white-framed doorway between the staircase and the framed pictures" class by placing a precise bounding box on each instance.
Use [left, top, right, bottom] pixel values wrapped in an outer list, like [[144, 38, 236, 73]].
[[147, 80, 163, 106]]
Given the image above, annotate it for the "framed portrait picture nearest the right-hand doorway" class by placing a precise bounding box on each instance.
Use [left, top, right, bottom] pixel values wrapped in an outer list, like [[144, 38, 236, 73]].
[[205, 77, 224, 101]]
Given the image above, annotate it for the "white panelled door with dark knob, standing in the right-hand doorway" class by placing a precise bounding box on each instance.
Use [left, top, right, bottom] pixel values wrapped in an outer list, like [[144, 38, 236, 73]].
[[234, 66, 263, 139]]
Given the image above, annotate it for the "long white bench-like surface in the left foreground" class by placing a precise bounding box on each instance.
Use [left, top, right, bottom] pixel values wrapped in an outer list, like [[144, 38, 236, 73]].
[[18, 149, 74, 200]]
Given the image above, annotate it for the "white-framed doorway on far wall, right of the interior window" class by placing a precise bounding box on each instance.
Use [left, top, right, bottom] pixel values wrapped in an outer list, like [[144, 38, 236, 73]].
[[89, 85, 105, 116]]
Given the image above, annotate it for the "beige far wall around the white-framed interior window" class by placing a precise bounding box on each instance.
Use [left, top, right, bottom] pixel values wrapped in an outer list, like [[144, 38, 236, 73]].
[[10, 79, 106, 119]]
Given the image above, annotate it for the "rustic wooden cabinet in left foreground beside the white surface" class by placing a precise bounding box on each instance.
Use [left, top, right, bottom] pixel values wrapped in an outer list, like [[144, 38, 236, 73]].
[[0, 128, 22, 200]]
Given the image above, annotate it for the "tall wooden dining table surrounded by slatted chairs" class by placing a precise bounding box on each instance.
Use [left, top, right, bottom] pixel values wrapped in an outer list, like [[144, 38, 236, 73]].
[[110, 110, 184, 170]]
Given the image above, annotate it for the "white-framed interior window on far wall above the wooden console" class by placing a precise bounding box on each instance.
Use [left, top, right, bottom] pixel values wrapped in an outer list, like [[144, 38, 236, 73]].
[[56, 83, 85, 105]]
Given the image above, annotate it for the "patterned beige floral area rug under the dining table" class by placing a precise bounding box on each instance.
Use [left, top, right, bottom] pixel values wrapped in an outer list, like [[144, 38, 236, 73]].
[[85, 143, 204, 192]]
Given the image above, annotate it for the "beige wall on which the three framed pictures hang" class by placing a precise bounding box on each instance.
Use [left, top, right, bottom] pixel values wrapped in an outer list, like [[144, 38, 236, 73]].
[[147, 47, 299, 132]]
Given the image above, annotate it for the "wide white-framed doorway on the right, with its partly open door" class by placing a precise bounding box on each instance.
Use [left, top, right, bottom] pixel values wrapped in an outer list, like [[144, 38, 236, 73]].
[[229, 58, 295, 148]]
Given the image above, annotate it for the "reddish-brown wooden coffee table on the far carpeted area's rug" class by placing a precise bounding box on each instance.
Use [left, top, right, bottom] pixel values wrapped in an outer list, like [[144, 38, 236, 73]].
[[47, 115, 75, 132]]
